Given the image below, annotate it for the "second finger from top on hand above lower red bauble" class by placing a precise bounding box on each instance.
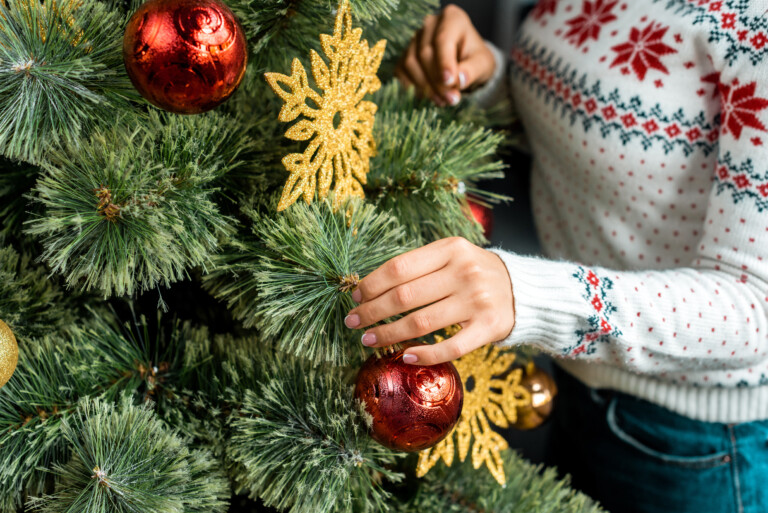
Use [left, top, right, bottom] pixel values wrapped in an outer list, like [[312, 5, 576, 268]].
[[346, 270, 454, 329]]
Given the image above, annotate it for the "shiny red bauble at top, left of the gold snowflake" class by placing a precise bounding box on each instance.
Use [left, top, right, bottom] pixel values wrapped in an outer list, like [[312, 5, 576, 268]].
[[123, 0, 248, 114]]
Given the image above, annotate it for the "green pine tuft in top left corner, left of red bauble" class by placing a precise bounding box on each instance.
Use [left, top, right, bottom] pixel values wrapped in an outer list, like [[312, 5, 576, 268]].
[[0, 0, 136, 163]]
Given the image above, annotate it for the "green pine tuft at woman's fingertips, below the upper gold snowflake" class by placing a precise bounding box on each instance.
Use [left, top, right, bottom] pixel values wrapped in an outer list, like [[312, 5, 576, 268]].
[[204, 200, 412, 364]]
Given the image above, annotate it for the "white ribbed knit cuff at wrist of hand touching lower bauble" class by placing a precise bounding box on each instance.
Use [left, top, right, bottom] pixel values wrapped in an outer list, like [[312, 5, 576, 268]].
[[491, 249, 589, 354]]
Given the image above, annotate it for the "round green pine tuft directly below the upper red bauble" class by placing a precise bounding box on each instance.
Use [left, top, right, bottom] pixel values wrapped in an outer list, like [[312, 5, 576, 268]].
[[28, 114, 250, 296]]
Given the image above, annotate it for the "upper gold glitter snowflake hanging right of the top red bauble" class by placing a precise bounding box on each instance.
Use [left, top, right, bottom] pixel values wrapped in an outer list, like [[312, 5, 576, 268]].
[[265, 0, 387, 212]]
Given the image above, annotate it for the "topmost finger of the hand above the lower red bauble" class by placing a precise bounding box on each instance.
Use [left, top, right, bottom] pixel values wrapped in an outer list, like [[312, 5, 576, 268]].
[[352, 237, 466, 303]]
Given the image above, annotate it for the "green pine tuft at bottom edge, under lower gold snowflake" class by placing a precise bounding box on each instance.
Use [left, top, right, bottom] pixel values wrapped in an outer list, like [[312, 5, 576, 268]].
[[398, 450, 603, 513]]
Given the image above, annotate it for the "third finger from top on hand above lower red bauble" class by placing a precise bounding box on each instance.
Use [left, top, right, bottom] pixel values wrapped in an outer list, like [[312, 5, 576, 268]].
[[361, 298, 467, 347]]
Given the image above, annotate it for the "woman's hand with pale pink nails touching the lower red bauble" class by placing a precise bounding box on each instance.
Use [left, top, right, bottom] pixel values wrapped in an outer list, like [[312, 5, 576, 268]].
[[344, 237, 515, 365]]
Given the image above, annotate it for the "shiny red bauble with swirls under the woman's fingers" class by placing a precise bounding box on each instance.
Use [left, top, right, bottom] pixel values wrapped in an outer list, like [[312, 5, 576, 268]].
[[355, 342, 464, 452]]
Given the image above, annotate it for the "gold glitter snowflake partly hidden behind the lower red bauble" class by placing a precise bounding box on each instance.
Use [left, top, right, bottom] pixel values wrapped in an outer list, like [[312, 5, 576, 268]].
[[416, 328, 531, 486]]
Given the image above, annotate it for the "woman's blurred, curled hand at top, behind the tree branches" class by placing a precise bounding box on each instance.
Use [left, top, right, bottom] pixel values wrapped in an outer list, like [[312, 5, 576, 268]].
[[395, 5, 496, 106]]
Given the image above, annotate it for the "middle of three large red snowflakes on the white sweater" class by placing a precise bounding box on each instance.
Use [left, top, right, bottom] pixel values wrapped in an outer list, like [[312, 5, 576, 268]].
[[611, 22, 677, 81]]
